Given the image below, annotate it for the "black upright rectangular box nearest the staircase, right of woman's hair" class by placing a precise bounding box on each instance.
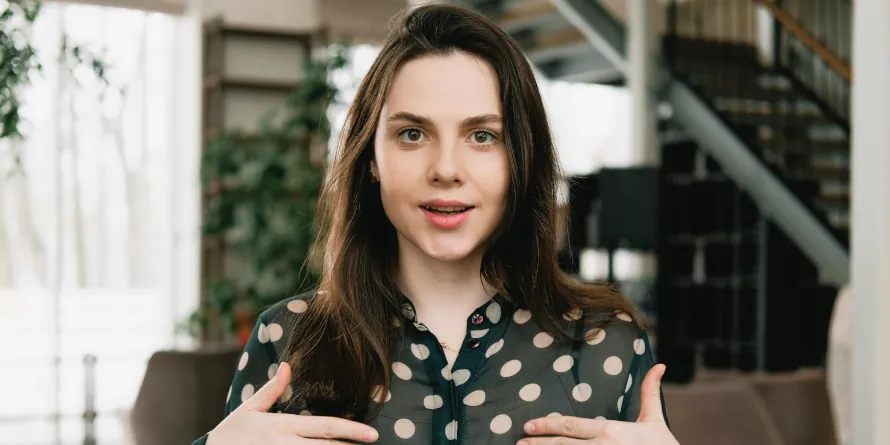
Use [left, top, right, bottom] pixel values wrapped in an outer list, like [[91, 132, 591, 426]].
[[598, 167, 660, 251]]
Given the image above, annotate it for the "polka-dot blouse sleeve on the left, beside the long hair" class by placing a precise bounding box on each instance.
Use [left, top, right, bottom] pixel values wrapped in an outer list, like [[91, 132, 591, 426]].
[[225, 315, 281, 416]]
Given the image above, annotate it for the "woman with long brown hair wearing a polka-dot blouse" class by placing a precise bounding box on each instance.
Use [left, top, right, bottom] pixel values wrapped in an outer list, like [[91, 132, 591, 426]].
[[197, 5, 676, 445]]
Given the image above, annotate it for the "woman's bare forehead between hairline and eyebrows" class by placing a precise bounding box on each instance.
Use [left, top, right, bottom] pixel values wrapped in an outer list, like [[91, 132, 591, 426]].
[[384, 52, 501, 120]]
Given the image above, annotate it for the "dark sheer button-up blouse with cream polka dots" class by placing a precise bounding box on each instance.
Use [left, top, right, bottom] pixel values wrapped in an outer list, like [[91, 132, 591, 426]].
[[193, 296, 655, 445]]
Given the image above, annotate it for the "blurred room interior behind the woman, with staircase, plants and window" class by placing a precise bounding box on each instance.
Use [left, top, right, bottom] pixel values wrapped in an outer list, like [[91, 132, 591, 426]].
[[0, 0, 890, 445]]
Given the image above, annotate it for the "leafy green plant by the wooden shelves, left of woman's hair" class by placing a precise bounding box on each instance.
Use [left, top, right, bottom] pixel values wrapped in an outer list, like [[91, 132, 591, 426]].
[[189, 47, 346, 342]]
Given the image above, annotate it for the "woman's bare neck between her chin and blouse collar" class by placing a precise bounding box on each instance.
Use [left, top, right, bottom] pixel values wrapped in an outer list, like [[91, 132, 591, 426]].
[[397, 240, 494, 323]]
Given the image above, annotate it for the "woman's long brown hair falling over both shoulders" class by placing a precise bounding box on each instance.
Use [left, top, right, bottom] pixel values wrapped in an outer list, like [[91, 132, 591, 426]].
[[285, 4, 635, 420]]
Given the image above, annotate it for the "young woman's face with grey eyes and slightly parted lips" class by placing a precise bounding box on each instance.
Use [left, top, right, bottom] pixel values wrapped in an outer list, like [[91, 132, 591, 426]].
[[371, 52, 509, 262]]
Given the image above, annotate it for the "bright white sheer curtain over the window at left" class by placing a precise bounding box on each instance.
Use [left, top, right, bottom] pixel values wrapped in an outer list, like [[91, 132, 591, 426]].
[[0, 3, 191, 445]]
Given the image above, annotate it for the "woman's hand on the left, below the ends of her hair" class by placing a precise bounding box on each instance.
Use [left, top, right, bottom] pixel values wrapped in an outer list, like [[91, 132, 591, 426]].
[[207, 363, 377, 445]]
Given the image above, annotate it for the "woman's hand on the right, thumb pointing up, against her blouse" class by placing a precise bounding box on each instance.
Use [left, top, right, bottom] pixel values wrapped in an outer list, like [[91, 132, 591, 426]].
[[518, 365, 679, 445]]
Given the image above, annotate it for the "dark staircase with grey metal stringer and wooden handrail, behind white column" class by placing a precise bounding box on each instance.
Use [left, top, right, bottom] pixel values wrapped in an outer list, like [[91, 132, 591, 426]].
[[462, 0, 852, 374]]
